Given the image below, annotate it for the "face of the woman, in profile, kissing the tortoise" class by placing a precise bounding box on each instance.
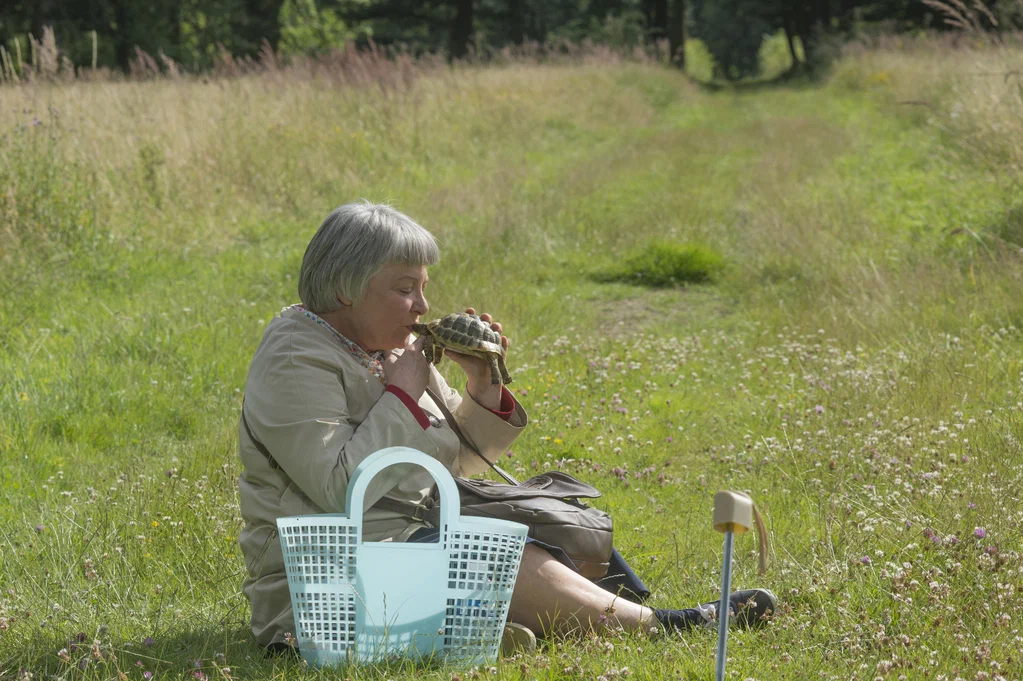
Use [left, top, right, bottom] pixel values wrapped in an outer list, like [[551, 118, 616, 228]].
[[342, 264, 430, 352]]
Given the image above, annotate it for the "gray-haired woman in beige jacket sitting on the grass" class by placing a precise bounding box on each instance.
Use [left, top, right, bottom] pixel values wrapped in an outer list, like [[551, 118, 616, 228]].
[[238, 203, 774, 650]]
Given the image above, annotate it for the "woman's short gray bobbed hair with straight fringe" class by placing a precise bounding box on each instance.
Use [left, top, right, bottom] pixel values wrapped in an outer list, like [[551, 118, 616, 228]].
[[299, 201, 440, 314]]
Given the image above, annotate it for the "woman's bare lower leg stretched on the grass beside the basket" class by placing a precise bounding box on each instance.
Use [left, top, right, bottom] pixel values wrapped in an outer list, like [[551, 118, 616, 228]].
[[509, 544, 659, 634]]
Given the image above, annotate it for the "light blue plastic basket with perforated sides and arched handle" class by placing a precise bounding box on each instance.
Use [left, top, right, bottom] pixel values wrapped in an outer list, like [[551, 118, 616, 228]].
[[277, 447, 527, 667]]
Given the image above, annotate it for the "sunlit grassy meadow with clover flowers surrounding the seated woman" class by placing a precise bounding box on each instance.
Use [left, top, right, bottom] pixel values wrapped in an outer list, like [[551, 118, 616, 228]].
[[0, 38, 1023, 681]]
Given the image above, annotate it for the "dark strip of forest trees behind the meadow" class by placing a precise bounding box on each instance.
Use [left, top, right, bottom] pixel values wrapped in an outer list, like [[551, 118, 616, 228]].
[[6, 0, 1023, 82]]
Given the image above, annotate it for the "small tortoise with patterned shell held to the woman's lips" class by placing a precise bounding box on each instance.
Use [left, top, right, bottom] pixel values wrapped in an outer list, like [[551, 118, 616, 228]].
[[412, 312, 512, 384]]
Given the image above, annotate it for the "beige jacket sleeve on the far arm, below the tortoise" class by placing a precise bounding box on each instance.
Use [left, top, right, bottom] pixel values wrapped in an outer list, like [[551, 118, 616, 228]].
[[431, 370, 529, 475]]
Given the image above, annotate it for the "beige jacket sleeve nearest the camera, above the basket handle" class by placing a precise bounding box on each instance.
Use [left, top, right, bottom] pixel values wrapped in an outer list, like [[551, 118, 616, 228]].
[[244, 331, 436, 512]]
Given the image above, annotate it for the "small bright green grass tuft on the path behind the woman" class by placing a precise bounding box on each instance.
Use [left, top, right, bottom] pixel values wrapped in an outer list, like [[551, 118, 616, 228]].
[[594, 241, 724, 287]]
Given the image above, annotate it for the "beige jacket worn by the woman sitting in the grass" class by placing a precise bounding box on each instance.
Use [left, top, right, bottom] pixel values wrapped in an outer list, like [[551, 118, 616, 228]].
[[238, 308, 527, 645]]
